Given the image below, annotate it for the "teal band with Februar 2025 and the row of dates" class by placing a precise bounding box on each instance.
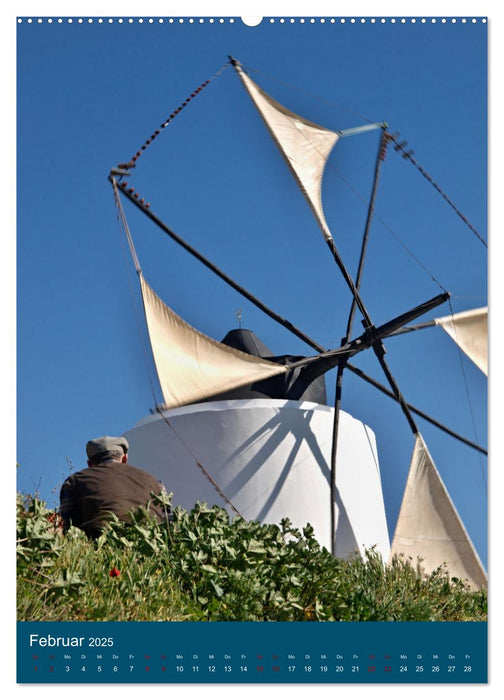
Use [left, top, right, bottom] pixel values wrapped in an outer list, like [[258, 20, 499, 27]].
[[17, 622, 488, 683]]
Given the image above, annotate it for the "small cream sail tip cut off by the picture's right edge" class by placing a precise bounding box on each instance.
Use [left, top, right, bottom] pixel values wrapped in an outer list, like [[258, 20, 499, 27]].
[[435, 306, 488, 375]]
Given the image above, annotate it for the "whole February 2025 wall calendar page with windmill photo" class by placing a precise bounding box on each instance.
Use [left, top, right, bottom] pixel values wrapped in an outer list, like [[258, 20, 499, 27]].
[[15, 6, 488, 687]]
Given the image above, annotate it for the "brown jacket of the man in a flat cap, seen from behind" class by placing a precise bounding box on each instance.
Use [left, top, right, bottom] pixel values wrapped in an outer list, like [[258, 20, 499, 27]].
[[60, 462, 167, 538]]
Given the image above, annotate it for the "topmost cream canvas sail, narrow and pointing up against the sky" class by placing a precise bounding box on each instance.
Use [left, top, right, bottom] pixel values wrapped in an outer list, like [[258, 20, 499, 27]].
[[236, 66, 339, 240]]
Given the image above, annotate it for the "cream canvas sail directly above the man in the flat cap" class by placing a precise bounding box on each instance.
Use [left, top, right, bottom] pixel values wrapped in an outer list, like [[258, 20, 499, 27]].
[[139, 274, 287, 408]]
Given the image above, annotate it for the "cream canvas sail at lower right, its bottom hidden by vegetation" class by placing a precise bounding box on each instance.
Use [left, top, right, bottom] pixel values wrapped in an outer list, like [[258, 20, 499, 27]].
[[390, 434, 487, 589]]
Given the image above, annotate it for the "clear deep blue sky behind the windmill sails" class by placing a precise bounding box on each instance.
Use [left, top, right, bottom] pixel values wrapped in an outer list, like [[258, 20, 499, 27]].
[[16, 17, 487, 564]]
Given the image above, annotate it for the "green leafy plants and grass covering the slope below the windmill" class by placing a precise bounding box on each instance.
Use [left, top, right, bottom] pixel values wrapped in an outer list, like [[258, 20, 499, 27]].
[[17, 495, 487, 621]]
